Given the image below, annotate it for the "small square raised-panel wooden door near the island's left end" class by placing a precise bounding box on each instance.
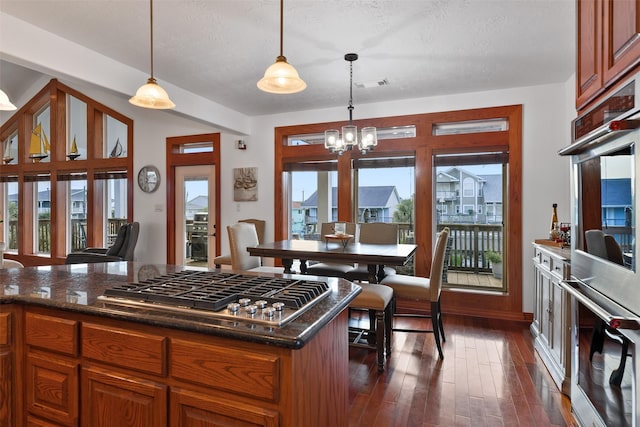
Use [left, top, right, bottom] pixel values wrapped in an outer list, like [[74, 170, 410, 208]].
[[25, 354, 79, 426]]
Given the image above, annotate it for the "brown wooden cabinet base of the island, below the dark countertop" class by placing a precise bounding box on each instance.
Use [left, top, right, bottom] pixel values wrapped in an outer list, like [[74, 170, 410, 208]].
[[15, 307, 349, 427]]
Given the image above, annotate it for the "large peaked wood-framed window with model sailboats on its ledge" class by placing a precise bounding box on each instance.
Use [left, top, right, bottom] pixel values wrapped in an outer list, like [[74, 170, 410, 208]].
[[0, 80, 133, 264]]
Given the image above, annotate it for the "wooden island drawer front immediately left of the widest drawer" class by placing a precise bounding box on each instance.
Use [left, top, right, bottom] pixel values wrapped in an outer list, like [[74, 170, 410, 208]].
[[82, 323, 167, 376]]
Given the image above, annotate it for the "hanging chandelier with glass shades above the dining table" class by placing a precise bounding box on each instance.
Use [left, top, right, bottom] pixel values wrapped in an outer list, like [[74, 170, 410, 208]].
[[324, 53, 378, 155]]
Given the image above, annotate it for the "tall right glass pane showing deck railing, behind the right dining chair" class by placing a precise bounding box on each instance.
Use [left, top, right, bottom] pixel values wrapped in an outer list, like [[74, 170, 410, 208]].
[[433, 154, 506, 291]]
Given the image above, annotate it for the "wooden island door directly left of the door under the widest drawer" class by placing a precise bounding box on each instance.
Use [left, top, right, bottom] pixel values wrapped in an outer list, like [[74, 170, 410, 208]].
[[81, 368, 167, 427]]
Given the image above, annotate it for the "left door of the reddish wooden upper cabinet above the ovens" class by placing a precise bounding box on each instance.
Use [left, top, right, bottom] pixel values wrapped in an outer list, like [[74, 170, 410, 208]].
[[576, 0, 604, 109]]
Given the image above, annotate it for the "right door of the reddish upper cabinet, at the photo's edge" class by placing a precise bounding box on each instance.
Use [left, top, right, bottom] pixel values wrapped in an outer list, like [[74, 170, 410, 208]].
[[602, 0, 640, 86]]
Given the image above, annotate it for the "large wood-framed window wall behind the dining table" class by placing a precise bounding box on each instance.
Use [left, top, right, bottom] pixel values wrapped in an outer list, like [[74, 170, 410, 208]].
[[274, 105, 523, 316]]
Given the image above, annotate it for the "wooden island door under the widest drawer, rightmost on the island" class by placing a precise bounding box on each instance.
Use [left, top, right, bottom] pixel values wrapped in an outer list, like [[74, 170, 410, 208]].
[[170, 389, 279, 427]]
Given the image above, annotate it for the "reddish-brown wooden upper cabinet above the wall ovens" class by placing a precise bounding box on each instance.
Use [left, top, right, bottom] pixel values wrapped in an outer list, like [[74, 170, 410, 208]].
[[576, 0, 640, 110]]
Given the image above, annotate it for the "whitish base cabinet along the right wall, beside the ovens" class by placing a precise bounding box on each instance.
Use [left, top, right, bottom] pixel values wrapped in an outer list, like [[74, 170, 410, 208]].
[[531, 245, 571, 395]]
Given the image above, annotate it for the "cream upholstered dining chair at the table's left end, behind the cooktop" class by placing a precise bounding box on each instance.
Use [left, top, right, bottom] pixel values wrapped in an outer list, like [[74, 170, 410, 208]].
[[227, 222, 283, 273]]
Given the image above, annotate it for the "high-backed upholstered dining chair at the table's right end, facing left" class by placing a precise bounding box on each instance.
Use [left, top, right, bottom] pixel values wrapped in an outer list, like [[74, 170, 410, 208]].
[[380, 227, 449, 359]]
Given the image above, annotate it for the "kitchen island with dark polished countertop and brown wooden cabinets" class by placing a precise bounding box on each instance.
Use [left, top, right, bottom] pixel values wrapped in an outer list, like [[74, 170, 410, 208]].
[[0, 262, 360, 427]]
